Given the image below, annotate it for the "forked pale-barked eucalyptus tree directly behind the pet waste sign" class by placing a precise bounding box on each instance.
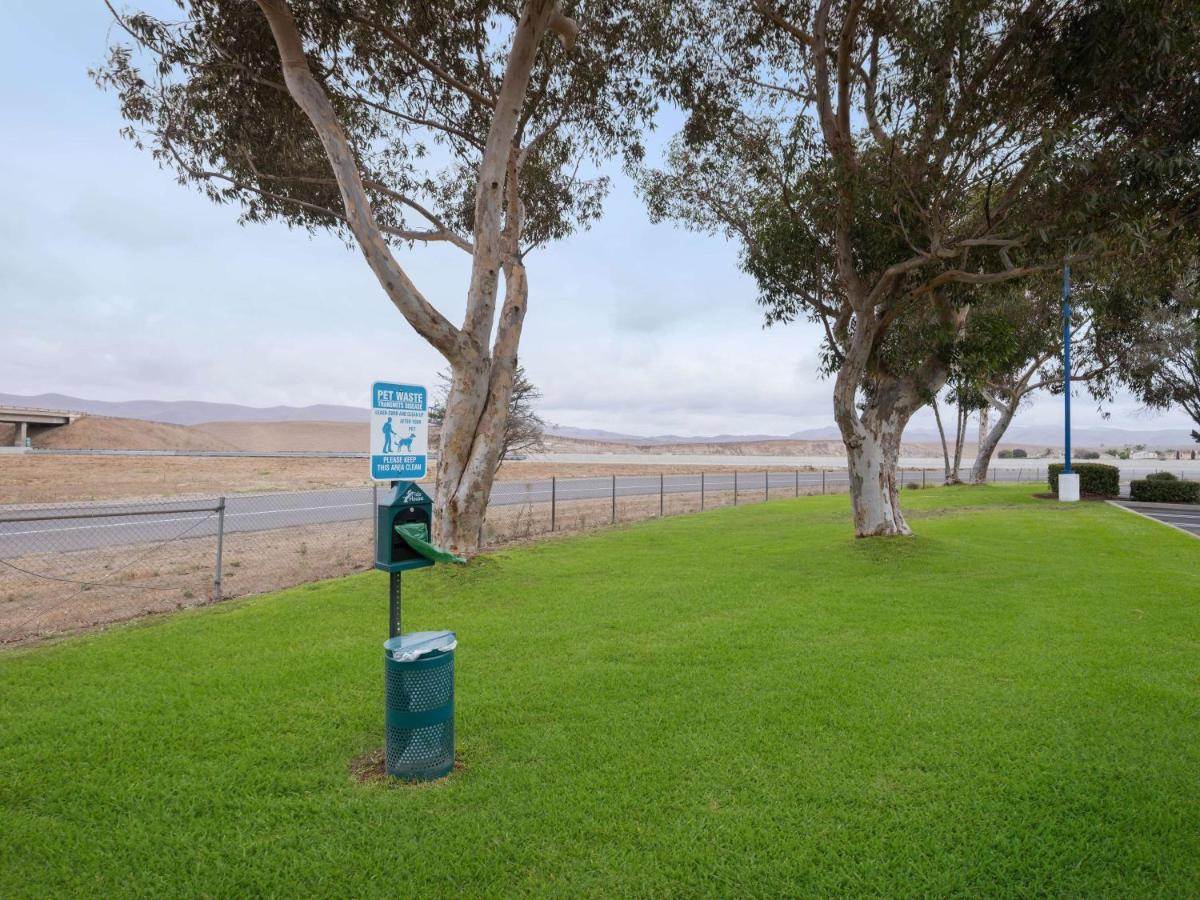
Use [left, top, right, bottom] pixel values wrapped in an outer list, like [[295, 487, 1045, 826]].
[[94, 0, 654, 552]]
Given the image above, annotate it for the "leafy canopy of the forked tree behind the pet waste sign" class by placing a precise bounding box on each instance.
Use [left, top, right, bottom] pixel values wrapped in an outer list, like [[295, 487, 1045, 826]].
[[95, 0, 654, 264]]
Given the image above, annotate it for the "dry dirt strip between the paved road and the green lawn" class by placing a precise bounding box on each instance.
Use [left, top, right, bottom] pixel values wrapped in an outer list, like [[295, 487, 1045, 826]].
[[0, 488, 864, 646]]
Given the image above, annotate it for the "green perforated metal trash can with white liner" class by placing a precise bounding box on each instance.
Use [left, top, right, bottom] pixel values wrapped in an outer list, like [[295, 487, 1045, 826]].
[[384, 631, 457, 781]]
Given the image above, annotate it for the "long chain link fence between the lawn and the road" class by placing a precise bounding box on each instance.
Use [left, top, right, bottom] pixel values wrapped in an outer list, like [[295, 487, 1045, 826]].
[[0, 466, 1180, 643]]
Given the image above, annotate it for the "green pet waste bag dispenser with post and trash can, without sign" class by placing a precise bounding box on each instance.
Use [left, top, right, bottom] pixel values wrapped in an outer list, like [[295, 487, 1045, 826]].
[[376, 481, 464, 780]]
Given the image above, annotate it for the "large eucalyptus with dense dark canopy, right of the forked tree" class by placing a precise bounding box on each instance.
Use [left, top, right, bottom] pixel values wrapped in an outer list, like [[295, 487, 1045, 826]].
[[642, 0, 1200, 536]]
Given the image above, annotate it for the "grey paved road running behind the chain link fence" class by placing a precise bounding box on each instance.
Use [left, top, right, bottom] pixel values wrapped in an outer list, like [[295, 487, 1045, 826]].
[[0, 468, 1033, 558]]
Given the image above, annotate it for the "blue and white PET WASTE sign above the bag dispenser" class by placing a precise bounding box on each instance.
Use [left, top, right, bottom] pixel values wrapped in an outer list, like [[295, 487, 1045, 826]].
[[371, 382, 430, 481]]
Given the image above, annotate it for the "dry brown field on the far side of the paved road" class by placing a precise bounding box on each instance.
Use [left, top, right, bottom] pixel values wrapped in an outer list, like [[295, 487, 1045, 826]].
[[0, 454, 825, 504]]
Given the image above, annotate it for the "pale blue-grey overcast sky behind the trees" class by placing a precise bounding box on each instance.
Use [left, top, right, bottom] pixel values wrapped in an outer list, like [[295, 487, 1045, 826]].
[[0, 0, 1189, 434]]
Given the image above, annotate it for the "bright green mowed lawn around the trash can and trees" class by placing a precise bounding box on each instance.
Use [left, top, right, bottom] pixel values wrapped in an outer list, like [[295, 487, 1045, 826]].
[[0, 486, 1200, 896]]
